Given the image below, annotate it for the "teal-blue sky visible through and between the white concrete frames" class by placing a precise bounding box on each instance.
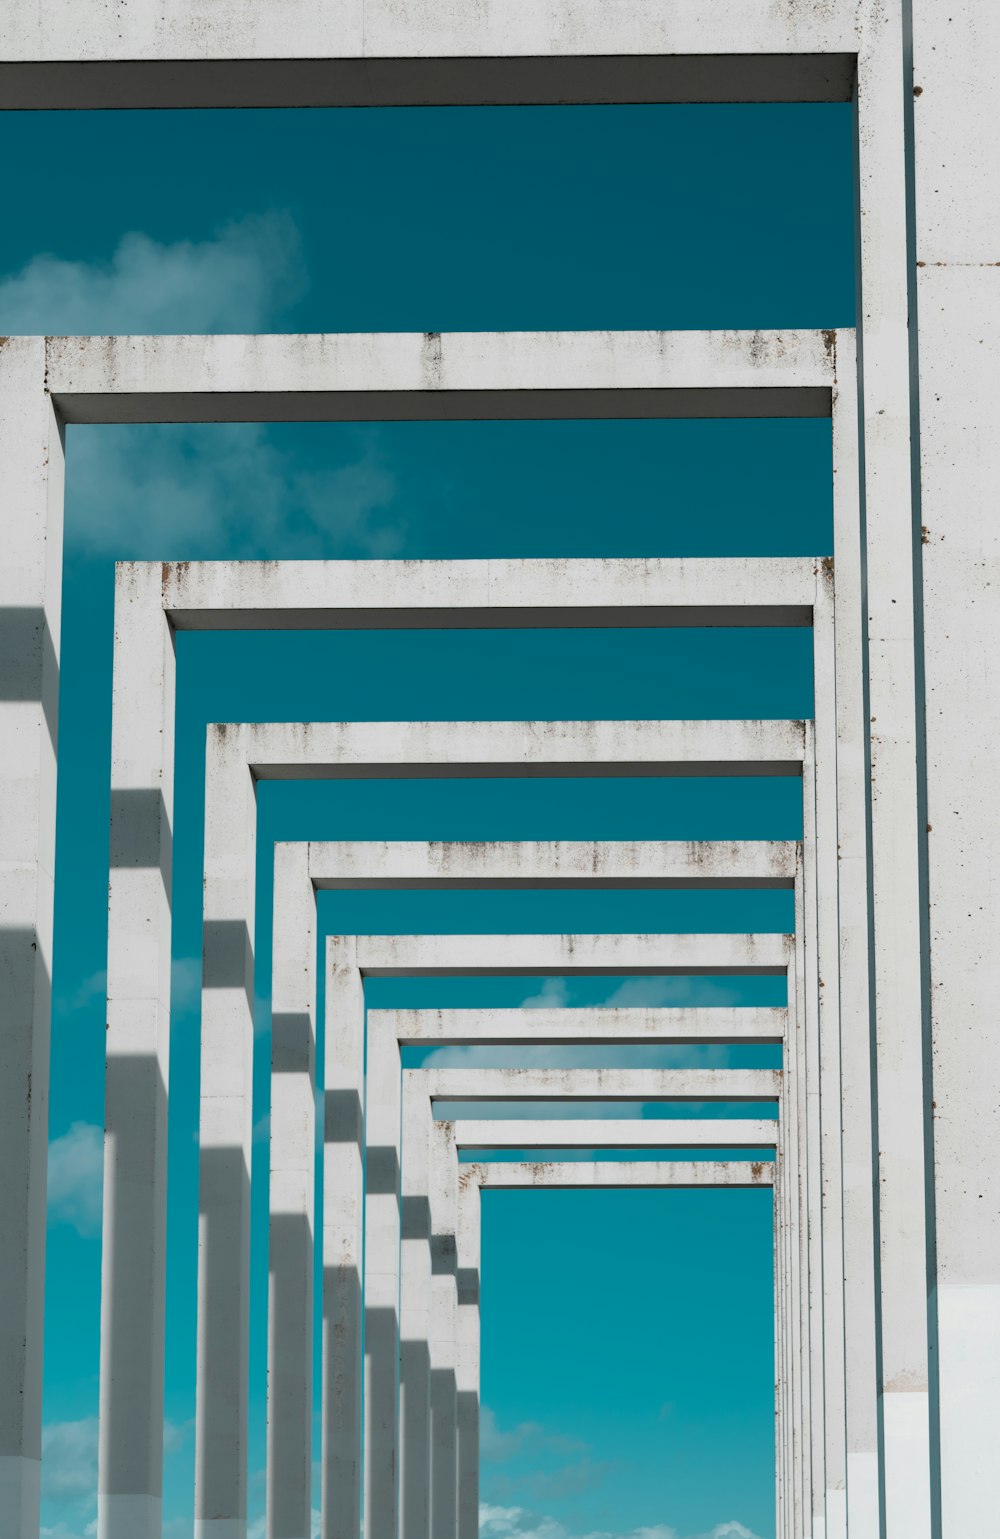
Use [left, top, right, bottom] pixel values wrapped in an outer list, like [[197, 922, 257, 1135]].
[[0, 106, 854, 1539]]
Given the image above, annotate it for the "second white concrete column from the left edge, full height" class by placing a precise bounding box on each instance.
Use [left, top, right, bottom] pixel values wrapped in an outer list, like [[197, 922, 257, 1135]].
[[97, 563, 174, 1539]]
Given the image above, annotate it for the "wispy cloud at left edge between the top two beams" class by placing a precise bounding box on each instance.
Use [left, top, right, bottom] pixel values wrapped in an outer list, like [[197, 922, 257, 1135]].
[[0, 212, 306, 336]]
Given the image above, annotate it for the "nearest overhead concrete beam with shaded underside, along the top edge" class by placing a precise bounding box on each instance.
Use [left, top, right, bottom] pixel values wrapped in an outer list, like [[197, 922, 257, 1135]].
[[0, 0, 857, 108]]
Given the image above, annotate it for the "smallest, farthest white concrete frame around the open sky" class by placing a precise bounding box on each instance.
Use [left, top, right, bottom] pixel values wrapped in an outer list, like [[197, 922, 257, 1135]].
[[449, 1151, 780, 1539]]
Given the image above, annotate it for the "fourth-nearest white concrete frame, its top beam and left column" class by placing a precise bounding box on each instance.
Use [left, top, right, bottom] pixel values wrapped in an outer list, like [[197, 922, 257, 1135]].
[[195, 722, 812, 1539]]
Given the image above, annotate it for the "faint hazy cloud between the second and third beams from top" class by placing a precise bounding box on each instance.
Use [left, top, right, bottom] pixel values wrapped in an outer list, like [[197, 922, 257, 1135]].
[[66, 422, 405, 560]]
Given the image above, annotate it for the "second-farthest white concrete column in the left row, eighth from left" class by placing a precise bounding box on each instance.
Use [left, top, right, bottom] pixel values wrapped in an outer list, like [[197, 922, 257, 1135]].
[[427, 1120, 458, 1539]]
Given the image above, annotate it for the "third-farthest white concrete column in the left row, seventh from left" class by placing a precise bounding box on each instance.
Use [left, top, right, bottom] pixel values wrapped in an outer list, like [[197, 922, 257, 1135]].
[[400, 1093, 431, 1539]]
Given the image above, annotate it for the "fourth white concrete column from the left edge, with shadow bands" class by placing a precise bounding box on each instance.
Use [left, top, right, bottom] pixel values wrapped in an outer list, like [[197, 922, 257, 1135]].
[[268, 843, 315, 1539]]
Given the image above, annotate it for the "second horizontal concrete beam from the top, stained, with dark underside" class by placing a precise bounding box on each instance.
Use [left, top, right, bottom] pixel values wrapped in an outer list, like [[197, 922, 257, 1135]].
[[46, 331, 835, 421]]
